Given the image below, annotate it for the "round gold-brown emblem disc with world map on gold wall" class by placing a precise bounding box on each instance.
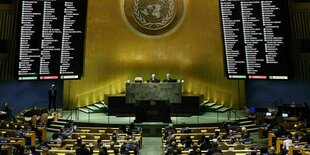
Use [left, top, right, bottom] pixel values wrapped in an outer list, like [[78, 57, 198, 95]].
[[124, 0, 184, 35]]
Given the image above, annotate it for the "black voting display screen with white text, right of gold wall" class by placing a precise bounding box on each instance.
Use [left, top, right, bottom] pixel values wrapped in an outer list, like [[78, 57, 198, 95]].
[[220, 0, 291, 79]]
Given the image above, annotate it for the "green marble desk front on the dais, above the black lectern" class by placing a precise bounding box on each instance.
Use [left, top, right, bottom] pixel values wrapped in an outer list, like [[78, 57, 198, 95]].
[[126, 83, 182, 103]]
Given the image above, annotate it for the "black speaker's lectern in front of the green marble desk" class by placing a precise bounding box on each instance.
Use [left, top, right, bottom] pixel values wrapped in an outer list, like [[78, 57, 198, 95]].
[[135, 100, 171, 123]]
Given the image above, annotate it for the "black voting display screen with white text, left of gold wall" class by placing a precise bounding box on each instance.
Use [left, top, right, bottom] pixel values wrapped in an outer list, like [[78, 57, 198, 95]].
[[16, 0, 87, 80]]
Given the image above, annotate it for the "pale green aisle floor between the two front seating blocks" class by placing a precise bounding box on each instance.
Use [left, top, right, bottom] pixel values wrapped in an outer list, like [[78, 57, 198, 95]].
[[140, 137, 162, 155]]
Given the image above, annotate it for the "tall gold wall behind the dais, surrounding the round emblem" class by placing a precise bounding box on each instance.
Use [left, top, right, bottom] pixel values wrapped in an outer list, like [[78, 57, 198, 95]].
[[64, 0, 245, 108]]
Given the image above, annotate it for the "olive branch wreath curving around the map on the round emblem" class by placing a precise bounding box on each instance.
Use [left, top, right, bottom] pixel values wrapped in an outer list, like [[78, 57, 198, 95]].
[[134, 0, 175, 27]]
